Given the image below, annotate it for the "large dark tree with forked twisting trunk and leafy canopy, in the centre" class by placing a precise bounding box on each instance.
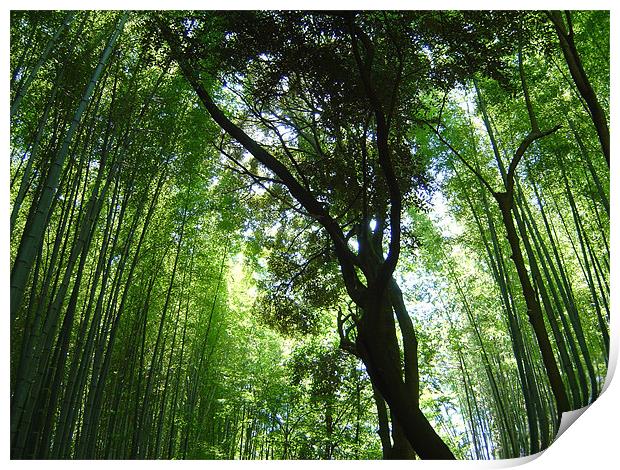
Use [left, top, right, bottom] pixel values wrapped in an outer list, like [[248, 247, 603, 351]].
[[158, 12, 528, 458]]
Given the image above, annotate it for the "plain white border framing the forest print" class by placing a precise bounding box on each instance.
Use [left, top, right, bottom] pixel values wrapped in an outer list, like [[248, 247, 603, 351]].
[[0, 0, 620, 470]]
